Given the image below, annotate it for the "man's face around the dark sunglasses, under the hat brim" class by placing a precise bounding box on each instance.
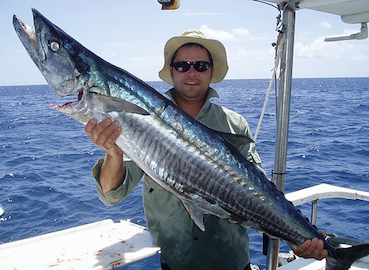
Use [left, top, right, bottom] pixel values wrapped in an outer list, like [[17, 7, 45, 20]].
[[170, 45, 214, 102]]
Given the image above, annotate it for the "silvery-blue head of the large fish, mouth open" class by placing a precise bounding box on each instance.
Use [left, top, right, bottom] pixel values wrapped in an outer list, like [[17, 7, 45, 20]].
[[13, 8, 88, 97]]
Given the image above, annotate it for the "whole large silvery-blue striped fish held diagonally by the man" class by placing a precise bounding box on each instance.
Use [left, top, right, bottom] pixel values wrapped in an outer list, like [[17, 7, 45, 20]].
[[13, 9, 369, 270]]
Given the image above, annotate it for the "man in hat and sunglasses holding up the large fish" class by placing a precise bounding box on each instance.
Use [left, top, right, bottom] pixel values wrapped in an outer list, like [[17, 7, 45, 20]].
[[85, 30, 326, 270]]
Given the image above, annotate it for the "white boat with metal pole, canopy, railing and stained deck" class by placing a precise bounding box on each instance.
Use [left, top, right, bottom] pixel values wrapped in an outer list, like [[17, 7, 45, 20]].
[[0, 0, 369, 270]]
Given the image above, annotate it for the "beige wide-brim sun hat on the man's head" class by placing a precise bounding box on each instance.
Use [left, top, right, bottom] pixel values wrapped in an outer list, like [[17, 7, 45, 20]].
[[159, 30, 228, 85]]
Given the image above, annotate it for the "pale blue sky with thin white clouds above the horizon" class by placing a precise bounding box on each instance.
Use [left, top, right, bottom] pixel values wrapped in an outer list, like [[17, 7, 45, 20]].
[[0, 0, 369, 86]]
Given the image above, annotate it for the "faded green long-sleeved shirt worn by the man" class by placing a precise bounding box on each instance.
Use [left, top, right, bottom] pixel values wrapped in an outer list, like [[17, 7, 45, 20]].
[[93, 88, 264, 270]]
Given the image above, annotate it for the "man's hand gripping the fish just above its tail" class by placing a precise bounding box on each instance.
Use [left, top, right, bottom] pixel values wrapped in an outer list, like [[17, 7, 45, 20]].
[[290, 238, 328, 260]]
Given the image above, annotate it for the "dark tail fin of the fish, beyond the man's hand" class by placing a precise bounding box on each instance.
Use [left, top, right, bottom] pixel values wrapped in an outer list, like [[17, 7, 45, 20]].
[[325, 244, 369, 270]]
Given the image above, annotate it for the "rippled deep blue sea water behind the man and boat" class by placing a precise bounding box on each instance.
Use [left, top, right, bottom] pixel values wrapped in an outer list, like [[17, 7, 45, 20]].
[[0, 78, 369, 270]]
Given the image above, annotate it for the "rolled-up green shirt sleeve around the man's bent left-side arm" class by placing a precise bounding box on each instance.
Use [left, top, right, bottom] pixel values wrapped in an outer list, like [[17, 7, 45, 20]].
[[92, 155, 144, 205]]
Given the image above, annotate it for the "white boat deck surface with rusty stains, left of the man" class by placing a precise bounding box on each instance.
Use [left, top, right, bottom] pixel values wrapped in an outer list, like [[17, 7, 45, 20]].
[[0, 219, 160, 270]]
